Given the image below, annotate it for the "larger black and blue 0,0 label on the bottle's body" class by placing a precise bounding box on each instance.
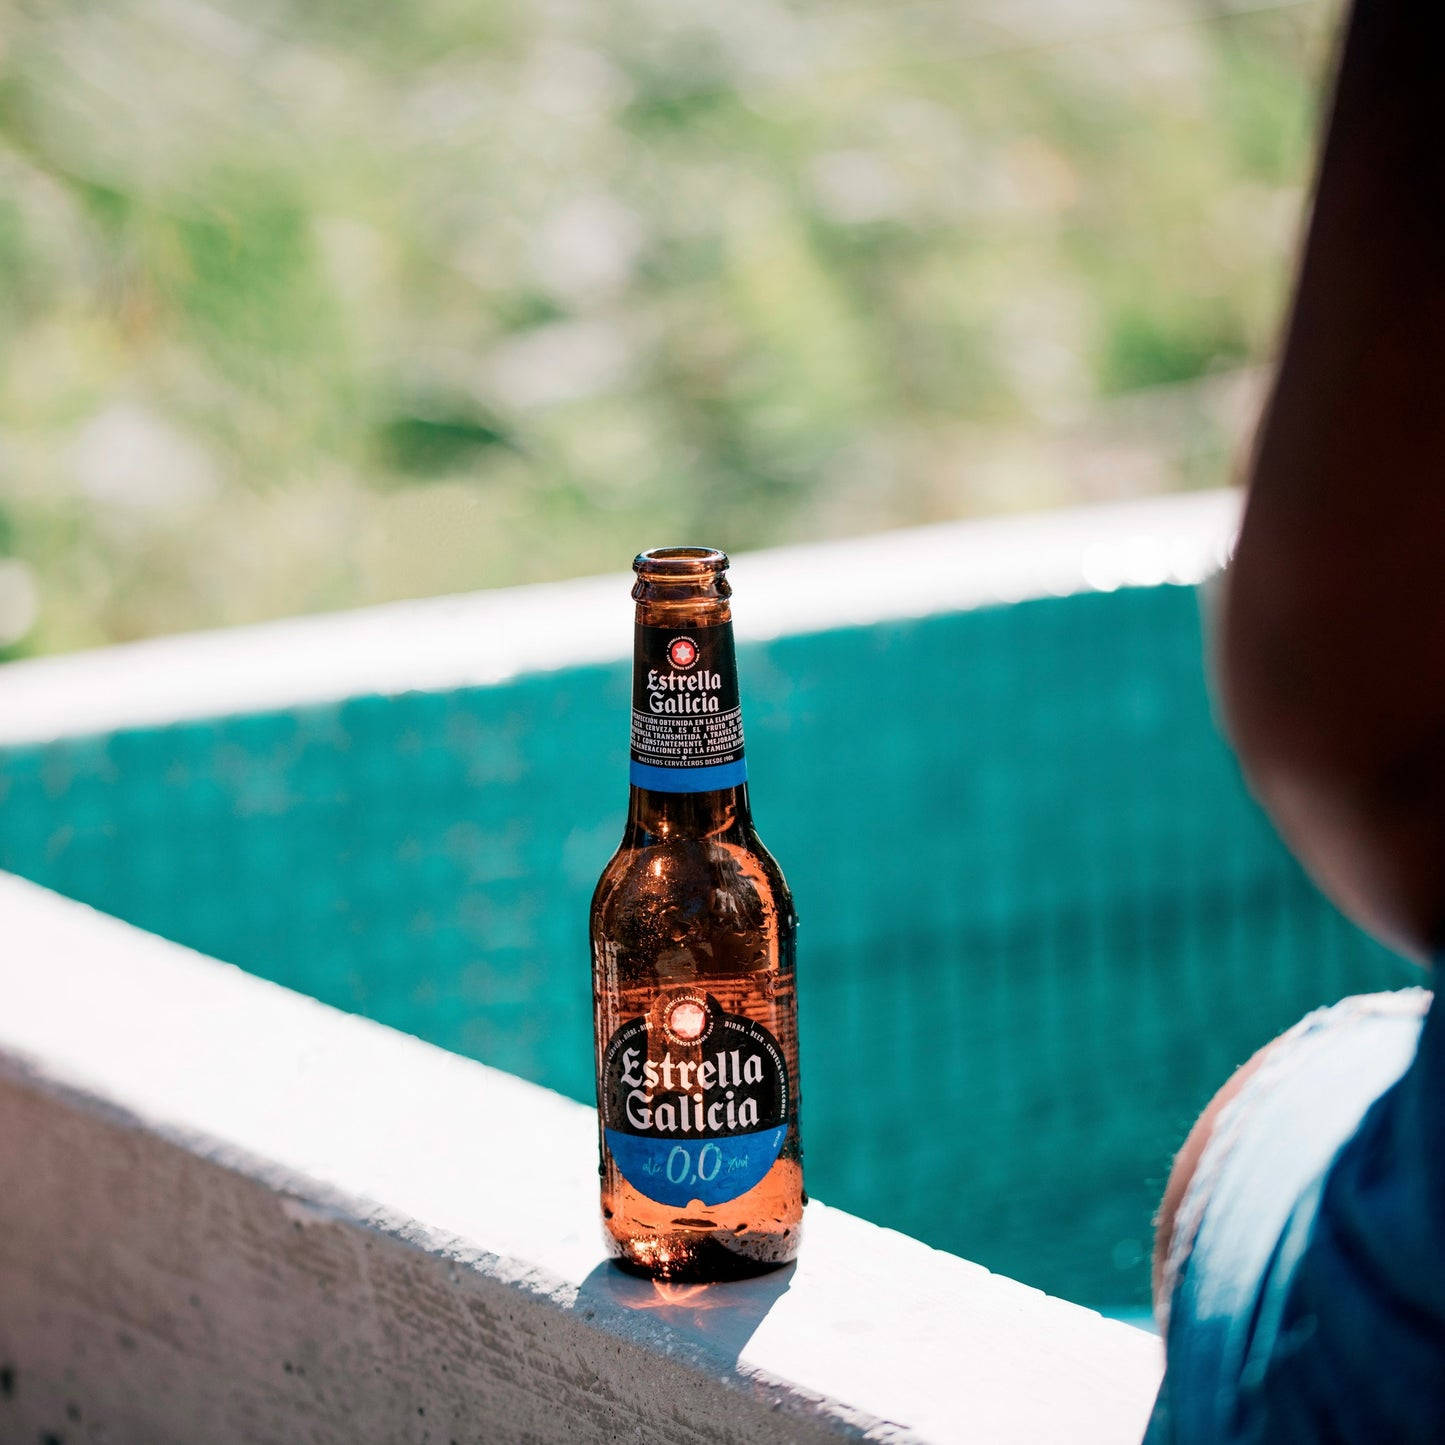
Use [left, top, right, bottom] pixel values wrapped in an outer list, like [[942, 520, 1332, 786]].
[[598, 988, 793, 1207]]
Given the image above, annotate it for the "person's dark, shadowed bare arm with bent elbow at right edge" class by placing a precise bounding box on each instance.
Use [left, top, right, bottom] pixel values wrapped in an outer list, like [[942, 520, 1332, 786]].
[[1218, 0, 1445, 957]]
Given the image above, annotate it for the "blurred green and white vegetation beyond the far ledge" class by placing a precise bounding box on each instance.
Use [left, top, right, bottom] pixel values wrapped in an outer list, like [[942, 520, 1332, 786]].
[[0, 0, 1338, 655]]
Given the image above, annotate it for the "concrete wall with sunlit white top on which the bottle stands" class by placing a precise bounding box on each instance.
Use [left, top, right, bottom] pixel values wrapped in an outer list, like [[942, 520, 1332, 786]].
[[0, 874, 1159, 1445]]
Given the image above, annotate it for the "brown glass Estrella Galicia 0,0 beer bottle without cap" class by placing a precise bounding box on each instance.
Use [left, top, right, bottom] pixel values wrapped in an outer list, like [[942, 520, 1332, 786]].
[[591, 548, 806, 1280]]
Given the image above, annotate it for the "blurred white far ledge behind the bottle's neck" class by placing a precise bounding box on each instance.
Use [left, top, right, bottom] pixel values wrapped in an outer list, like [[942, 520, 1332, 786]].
[[0, 491, 1240, 744]]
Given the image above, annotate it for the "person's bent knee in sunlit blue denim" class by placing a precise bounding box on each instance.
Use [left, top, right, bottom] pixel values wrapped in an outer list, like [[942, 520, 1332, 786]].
[[1150, 988, 1445, 1445]]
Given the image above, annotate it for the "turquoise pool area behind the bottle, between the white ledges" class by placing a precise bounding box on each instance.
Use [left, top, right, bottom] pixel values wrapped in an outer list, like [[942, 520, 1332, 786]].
[[0, 587, 1413, 1311]]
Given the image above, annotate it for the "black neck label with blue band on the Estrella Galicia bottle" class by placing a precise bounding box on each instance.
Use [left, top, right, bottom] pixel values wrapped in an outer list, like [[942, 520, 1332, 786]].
[[631, 623, 747, 793]]
